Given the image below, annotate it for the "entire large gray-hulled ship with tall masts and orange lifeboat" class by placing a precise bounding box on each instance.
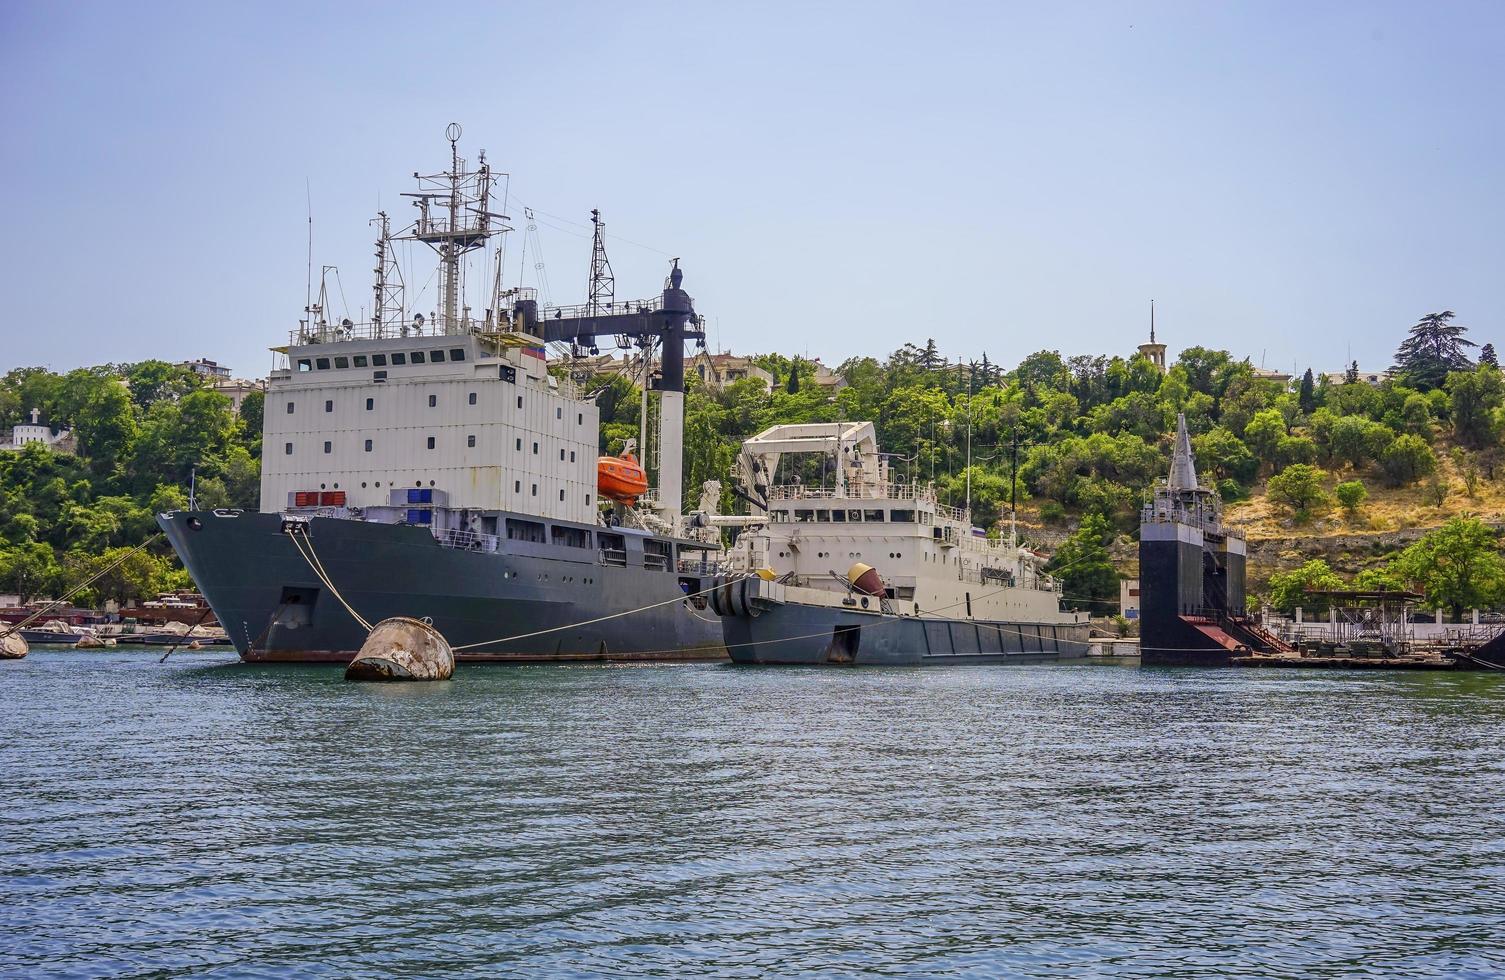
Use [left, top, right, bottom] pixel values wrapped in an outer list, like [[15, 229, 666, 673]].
[[158, 126, 725, 662]]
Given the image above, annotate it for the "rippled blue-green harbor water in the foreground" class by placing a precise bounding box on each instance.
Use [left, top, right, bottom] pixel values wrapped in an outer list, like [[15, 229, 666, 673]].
[[0, 650, 1505, 977]]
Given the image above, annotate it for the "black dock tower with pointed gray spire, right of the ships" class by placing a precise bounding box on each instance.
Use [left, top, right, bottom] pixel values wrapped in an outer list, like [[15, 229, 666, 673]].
[[1139, 415, 1294, 667]]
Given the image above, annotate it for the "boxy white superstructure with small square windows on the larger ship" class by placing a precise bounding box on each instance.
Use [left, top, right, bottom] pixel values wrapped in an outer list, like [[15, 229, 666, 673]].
[[262, 331, 599, 524]]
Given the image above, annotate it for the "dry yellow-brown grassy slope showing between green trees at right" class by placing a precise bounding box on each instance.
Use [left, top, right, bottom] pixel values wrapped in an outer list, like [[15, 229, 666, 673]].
[[1019, 446, 1505, 592]]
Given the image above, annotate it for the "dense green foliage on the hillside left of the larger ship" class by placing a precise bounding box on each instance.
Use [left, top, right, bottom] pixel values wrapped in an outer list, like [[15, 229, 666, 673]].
[[0, 361, 262, 602]]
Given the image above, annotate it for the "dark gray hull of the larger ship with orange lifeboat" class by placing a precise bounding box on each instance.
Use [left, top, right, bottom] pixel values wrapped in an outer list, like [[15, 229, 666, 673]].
[[158, 512, 725, 664]]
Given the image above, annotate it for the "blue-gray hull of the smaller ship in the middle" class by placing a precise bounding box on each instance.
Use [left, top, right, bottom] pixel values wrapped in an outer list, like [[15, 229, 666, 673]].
[[722, 602, 1088, 667]]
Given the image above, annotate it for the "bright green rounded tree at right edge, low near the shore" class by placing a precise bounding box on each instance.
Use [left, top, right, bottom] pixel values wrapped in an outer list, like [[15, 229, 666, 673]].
[[1395, 516, 1505, 619]]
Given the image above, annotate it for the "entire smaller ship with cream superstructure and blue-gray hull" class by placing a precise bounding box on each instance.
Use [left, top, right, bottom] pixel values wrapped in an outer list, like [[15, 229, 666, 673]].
[[706, 422, 1088, 665]]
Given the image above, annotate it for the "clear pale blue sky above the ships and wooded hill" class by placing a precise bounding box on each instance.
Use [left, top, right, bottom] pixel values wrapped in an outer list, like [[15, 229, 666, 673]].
[[0, 2, 1505, 376]]
